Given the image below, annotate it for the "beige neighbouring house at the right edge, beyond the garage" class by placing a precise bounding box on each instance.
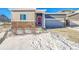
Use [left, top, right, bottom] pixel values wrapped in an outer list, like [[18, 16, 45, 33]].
[[59, 10, 79, 27]]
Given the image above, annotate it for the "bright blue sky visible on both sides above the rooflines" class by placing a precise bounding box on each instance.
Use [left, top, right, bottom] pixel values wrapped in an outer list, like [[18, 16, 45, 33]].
[[0, 8, 79, 18]]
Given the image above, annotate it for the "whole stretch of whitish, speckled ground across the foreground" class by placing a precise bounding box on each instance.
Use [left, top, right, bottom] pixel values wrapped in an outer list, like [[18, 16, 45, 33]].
[[0, 32, 79, 50]]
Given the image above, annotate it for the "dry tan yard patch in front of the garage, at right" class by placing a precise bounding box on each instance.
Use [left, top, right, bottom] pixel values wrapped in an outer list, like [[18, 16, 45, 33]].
[[49, 28, 79, 43]]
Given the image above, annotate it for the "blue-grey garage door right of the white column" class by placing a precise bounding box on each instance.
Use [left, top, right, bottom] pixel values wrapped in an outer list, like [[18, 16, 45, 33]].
[[45, 18, 64, 28]]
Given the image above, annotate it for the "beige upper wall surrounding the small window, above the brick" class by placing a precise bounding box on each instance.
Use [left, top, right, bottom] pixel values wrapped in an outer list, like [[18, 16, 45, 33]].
[[12, 12, 35, 21]]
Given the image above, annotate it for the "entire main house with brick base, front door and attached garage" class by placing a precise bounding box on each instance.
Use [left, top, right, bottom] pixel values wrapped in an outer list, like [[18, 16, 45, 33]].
[[11, 8, 66, 32]]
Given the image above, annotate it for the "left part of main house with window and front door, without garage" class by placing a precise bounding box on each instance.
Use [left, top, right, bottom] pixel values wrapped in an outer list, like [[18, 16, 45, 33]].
[[11, 8, 44, 32]]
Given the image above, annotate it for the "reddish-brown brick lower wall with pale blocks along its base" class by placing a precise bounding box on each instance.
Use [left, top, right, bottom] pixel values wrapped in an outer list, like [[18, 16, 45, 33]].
[[12, 21, 45, 34]]
